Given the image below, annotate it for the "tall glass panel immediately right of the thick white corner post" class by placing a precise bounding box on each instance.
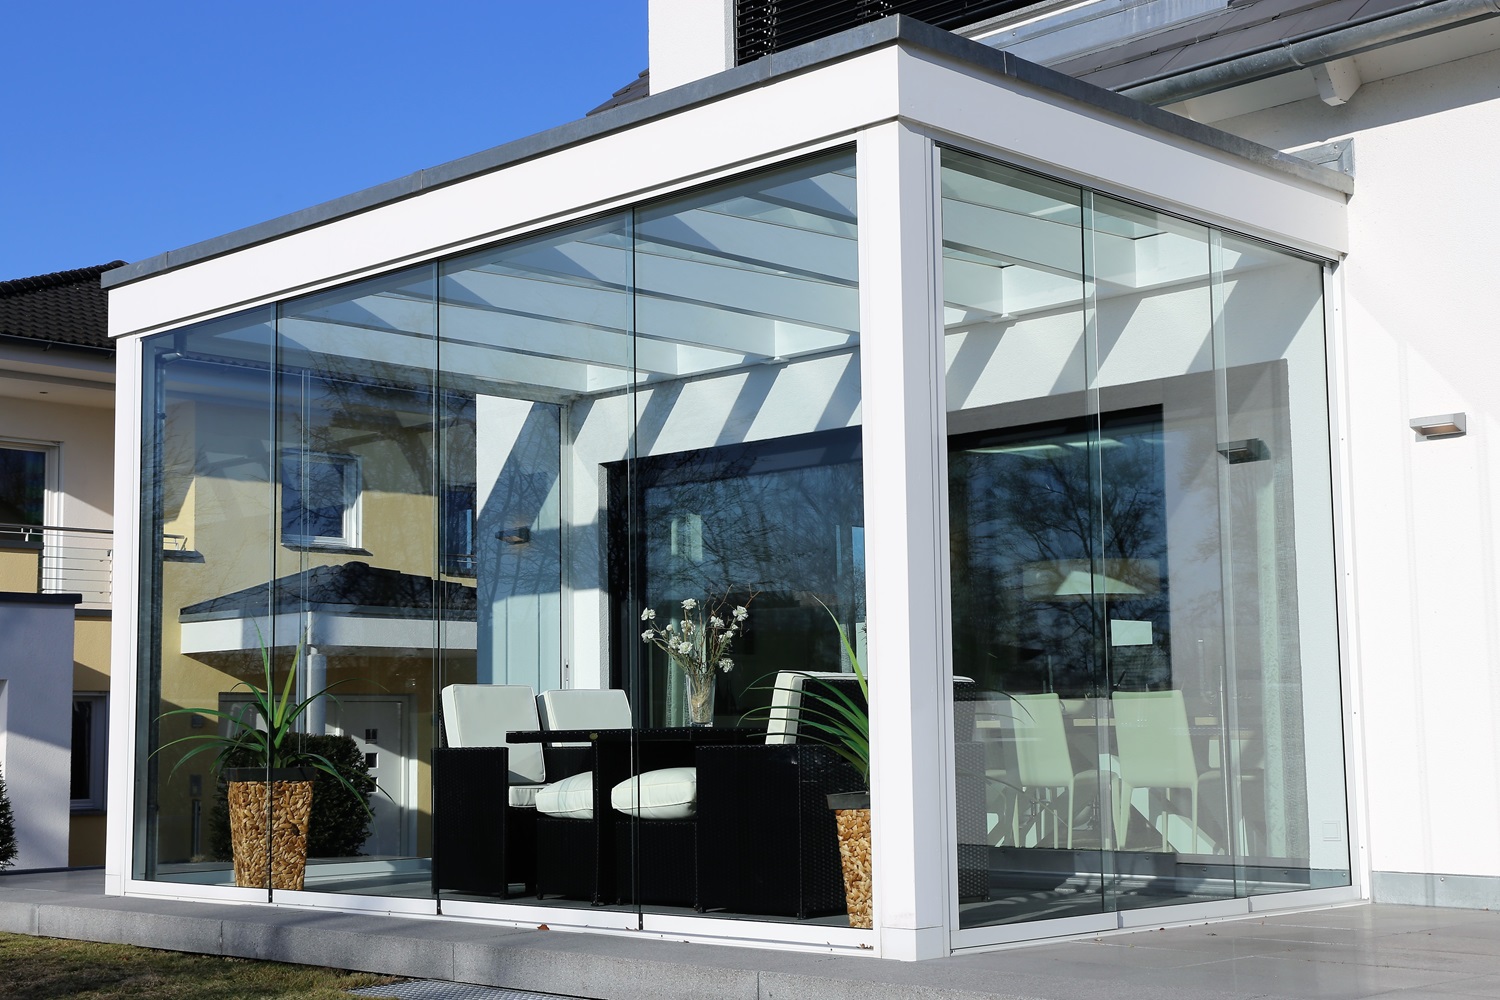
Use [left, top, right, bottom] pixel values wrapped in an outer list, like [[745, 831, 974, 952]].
[[942, 150, 1110, 927]]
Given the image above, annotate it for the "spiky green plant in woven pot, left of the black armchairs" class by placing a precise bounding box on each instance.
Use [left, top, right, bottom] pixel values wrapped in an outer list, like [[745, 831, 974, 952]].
[[153, 640, 372, 889]]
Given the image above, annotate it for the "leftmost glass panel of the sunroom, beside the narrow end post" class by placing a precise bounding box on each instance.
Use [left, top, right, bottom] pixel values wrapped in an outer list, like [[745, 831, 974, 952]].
[[135, 310, 276, 885]]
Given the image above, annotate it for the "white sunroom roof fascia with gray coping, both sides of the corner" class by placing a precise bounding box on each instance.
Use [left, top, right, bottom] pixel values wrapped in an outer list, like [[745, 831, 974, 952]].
[[105, 16, 1352, 336]]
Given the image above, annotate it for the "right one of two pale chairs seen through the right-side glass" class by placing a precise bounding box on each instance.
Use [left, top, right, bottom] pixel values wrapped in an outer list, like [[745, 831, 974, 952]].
[[1112, 690, 1220, 853]]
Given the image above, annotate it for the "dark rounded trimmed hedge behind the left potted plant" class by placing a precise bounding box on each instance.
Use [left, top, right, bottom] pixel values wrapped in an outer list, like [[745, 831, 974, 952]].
[[209, 736, 381, 861]]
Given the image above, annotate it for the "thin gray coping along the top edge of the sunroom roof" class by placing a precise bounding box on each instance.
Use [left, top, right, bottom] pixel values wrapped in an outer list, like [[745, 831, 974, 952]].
[[102, 15, 1353, 288]]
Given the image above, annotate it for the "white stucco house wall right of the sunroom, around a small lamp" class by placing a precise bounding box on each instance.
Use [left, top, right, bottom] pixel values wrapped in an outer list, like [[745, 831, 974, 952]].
[[1215, 44, 1500, 881]]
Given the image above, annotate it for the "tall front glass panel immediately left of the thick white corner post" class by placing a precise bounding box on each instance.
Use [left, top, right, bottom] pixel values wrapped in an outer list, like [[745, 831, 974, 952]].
[[611, 153, 866, 925]]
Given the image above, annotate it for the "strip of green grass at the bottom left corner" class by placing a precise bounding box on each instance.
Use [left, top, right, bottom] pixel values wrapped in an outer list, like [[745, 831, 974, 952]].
[[0, 934, 393, 1000]]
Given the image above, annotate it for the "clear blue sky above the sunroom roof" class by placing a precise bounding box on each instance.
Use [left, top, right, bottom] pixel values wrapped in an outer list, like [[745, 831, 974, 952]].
[[0, 0, 647, 280]]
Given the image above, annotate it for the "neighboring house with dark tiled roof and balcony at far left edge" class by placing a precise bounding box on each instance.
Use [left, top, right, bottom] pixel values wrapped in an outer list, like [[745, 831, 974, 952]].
[[0, 261, 123, 868]]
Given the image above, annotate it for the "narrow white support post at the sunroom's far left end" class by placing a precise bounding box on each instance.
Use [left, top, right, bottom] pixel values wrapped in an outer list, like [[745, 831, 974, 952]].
[[104, 337, 152, 895]]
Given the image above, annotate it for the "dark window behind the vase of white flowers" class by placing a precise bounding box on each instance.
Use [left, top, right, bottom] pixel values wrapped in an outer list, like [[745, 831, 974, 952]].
[[609, 427, 866, 726]]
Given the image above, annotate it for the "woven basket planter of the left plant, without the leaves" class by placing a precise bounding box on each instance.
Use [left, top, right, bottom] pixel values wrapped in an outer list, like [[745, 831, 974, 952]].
[[224, 768, 314, 889]]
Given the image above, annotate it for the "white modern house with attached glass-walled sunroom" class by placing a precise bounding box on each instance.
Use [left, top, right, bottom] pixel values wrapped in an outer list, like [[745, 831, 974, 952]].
[[96, 0, 1500, 960]]
